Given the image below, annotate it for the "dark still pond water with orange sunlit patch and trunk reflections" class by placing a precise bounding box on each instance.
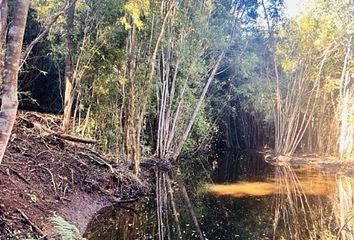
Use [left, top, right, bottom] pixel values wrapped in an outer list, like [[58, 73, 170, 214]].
[[85, 152, 354, 240]]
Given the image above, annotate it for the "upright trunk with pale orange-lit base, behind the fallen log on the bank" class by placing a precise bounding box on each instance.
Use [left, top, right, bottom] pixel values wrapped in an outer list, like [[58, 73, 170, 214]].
[[63, 0, 76, 132]]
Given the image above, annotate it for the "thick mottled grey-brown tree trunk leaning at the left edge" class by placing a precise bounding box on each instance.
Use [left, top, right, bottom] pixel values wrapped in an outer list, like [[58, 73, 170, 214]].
[[0, 0, 30, 163]]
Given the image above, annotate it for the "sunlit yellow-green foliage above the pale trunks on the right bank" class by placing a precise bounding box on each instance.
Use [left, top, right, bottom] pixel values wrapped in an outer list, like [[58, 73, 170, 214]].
[[276, 0, 354, 154]]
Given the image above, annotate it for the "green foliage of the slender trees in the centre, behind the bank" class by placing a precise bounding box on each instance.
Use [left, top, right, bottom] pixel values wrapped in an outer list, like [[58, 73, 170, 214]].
[[22, 0, 284, 158]]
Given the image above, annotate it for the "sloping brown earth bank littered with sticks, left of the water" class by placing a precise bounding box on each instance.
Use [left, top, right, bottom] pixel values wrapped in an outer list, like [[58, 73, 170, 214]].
[[0, 112, 150, 239]]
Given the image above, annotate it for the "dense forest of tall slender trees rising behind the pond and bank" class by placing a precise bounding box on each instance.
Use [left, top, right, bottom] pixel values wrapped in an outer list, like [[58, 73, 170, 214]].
[[0, 0, 354, 239]]
